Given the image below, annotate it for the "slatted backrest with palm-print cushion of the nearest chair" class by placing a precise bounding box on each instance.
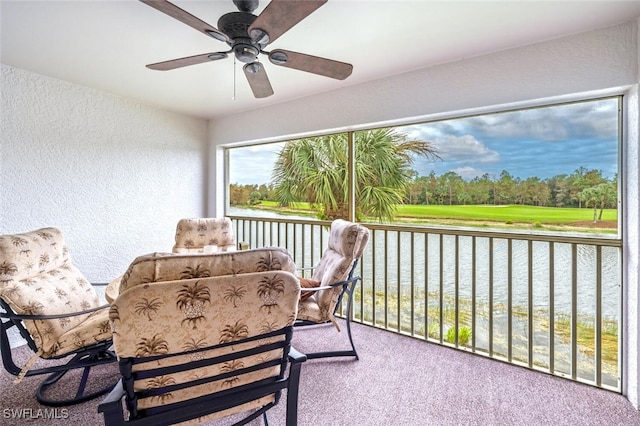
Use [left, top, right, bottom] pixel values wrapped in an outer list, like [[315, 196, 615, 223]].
[[110, 266, 300, 424]]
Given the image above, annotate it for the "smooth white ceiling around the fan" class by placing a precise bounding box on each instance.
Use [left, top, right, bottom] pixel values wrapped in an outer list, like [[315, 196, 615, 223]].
[[0, 0, 640, 118]]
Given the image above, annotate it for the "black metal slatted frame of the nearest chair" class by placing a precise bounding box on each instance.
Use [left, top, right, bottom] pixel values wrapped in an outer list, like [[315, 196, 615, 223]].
[[98, 326, 307, 426]]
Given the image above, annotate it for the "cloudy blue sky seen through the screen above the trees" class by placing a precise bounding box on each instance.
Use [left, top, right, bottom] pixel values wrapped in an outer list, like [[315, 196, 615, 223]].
[[230, 98, 618, 184]]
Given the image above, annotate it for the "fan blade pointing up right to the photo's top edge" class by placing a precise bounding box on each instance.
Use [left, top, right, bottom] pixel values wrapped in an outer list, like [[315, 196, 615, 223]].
[[248, 0, 328, 46]]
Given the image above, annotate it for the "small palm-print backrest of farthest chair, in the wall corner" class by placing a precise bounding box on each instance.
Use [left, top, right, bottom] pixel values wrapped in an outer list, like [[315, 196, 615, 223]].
[[172, 217, 237, 253]]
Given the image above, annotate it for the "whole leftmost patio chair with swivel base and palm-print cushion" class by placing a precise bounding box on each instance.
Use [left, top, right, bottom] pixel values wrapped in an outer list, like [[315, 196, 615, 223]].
[[0, 228, 116, 406]]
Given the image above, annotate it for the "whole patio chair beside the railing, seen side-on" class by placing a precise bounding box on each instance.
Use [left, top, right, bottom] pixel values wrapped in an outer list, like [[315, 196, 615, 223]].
[[296, 219, 369, 359]]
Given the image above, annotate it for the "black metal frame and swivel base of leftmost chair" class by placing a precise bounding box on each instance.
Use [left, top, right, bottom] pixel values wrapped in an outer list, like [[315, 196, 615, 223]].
[[0, 299, 117, 407]]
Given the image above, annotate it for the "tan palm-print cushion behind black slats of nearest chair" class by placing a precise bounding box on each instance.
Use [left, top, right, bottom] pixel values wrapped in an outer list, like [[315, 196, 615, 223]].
[[110, 270, 300, 421]]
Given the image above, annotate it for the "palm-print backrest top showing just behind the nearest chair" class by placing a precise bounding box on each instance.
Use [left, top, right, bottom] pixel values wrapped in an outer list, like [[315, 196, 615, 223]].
[[119, 247, 296, 293]]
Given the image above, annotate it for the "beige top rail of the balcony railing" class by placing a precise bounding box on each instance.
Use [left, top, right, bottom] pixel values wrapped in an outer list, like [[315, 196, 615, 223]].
[[228, 215, 622, 247]]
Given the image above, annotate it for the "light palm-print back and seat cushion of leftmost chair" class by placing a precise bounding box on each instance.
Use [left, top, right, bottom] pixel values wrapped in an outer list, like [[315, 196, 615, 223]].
[[0, 228, 104, 358]]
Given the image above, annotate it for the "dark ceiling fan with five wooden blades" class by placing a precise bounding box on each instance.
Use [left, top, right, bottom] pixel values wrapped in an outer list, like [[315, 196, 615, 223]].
[[140, 0, 353, 98]]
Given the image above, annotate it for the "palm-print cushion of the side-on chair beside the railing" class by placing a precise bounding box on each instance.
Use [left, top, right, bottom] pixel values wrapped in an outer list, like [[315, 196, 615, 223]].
[[298, 219, 369, 330]]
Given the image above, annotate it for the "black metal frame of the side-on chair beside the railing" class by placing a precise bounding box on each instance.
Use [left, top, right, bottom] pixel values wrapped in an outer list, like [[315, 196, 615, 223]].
[[294, 259, 362, 360]]
